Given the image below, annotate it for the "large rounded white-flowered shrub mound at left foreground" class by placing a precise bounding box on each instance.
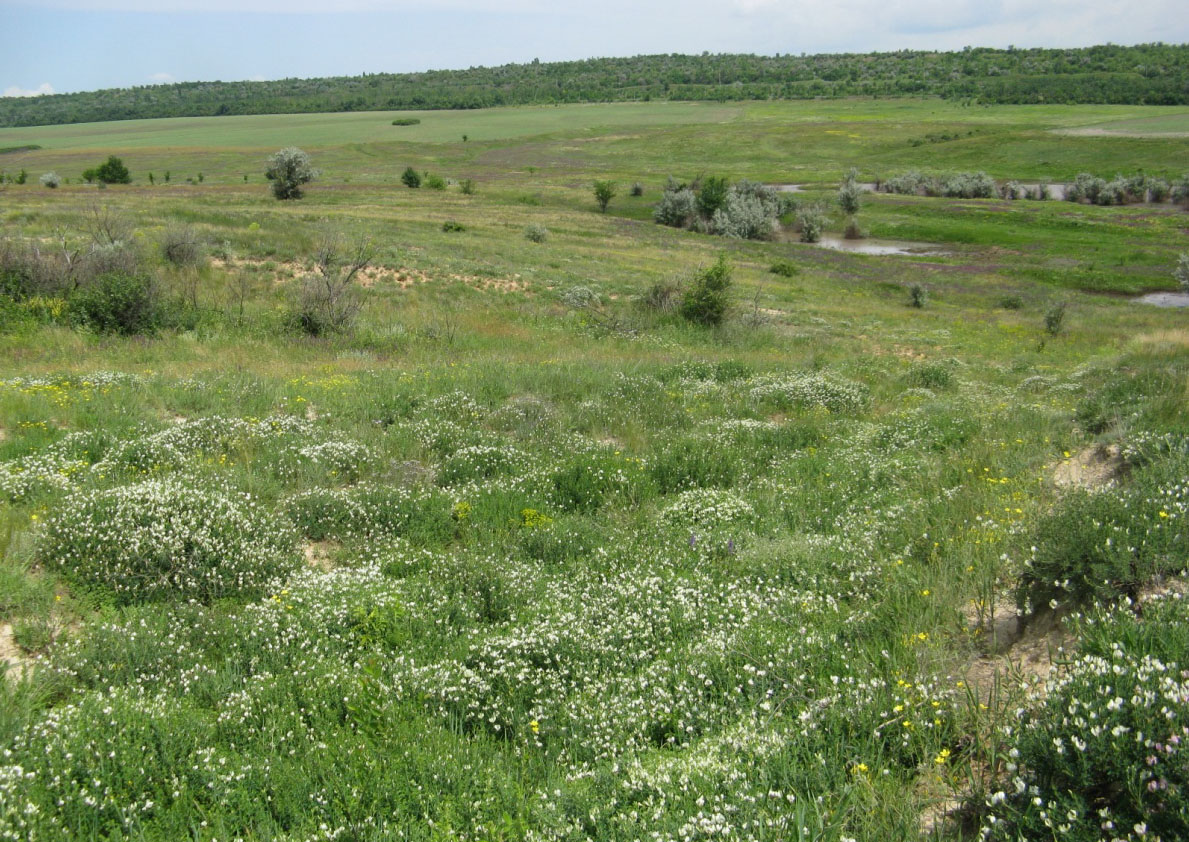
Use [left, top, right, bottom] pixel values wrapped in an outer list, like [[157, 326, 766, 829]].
[[38, 480, 297, 604]]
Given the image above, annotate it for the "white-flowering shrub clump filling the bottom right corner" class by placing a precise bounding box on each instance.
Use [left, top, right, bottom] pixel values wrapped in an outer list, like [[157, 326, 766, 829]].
[[982, 598, 1189, 842]]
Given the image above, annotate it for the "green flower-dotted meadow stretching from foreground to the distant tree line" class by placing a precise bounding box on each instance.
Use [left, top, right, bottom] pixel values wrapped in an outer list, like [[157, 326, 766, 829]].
[[0, 100, 1189, 842]]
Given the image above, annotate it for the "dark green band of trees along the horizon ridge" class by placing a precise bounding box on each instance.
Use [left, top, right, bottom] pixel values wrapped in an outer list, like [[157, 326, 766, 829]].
[[0, 43, 1189, 127]]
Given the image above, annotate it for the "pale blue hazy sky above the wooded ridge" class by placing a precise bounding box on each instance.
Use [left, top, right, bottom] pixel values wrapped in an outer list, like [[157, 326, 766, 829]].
[[0, 0, 1189, 96]]
